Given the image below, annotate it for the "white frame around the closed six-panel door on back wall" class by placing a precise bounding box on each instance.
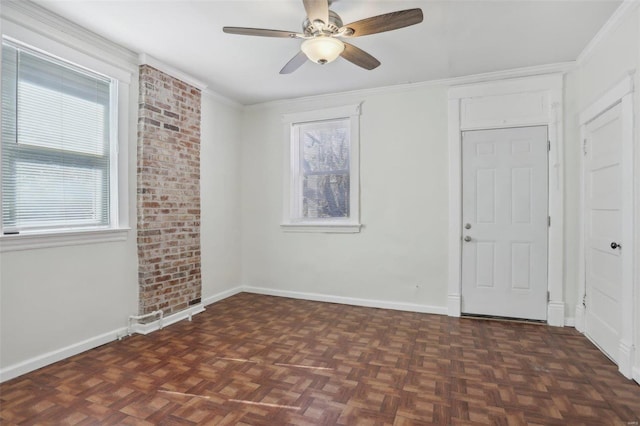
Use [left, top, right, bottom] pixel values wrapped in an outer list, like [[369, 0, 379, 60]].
[[447, 73, 565, 327]]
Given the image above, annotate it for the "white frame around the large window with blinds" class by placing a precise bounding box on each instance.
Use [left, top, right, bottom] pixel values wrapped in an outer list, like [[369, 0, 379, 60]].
[[0, 23, 132, 252]]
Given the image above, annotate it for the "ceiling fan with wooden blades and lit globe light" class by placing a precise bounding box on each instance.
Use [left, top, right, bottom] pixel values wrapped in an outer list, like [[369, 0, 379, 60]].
[[222, 0, 423, 74]]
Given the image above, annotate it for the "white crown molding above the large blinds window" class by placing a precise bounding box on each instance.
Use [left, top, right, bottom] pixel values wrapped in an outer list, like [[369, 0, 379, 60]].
[[0, 0, 137, 71]]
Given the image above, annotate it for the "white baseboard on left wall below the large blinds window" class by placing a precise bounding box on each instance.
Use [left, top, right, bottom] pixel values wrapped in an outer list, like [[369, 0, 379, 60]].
[[0, 327, 127, 383]]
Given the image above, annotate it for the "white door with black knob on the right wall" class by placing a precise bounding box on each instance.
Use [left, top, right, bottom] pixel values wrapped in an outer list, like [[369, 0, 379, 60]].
[[584, 104, 631, 362]]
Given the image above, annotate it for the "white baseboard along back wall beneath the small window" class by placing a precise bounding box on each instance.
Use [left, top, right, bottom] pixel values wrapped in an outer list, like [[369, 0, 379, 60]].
[[242, 286, 447, 315]]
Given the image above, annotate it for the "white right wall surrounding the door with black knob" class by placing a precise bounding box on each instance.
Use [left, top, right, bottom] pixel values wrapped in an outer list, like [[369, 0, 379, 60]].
[[565, 7, 640, 380]]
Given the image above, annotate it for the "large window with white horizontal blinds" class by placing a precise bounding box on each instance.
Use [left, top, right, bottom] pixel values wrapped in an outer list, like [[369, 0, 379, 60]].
[[0, 41, 116, 234]]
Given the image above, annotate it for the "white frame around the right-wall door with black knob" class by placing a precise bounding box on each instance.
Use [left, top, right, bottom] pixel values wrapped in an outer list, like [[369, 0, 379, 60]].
[[575, 72, 635, 379]]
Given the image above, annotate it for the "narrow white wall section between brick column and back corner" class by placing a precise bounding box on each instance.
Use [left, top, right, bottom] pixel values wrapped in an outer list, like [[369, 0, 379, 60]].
[[200, 91, 242, 304]]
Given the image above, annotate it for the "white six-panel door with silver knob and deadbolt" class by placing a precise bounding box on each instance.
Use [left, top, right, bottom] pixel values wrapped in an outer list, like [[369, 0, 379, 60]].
[[462, 126, 548, 320]]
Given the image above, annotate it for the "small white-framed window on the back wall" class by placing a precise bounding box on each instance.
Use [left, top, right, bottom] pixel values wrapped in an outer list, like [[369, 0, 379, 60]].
[[282, 105, 360, 232]]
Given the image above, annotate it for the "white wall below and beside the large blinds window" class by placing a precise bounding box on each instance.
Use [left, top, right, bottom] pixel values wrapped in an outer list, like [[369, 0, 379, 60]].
[[0, 77, 138, 379]]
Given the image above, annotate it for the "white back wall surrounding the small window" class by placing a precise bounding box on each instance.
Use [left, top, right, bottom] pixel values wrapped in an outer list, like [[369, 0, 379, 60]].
[[241, 86, 448, 313]]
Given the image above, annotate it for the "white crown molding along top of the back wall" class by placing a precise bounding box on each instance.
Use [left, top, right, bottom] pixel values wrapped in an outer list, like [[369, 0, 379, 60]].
[[243, 61, 576, 111]]
